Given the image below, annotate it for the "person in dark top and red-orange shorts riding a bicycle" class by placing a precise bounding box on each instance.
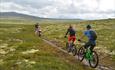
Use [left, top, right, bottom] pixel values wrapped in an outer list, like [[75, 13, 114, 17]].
[[65, 25, 76, 44]]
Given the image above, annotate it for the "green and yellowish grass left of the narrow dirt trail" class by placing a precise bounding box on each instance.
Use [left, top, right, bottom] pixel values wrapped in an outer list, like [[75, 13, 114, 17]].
[[0, 20, 92, 70]]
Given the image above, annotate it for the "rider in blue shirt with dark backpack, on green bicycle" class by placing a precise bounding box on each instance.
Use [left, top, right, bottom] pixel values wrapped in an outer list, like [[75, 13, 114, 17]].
[[78, 25, 97, 51]]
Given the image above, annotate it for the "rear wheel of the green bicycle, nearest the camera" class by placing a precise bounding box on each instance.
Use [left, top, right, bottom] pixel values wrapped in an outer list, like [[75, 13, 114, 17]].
[[89, 51, 99, 68]]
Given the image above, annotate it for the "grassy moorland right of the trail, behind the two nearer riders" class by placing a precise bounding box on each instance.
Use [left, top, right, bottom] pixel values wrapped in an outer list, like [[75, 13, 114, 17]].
[[42, 19, 115, 69]]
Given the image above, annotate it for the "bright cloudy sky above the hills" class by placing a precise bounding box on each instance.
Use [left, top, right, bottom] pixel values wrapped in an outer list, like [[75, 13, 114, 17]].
[[0, 0, 115, 19]]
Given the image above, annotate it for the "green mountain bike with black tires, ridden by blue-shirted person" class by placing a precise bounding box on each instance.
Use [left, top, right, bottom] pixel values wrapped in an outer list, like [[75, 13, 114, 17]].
[[78, 40, 99, 68]]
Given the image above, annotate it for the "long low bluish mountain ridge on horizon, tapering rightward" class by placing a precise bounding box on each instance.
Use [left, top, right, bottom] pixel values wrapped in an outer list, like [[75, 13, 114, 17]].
[[0, 12, 83, 21]]
